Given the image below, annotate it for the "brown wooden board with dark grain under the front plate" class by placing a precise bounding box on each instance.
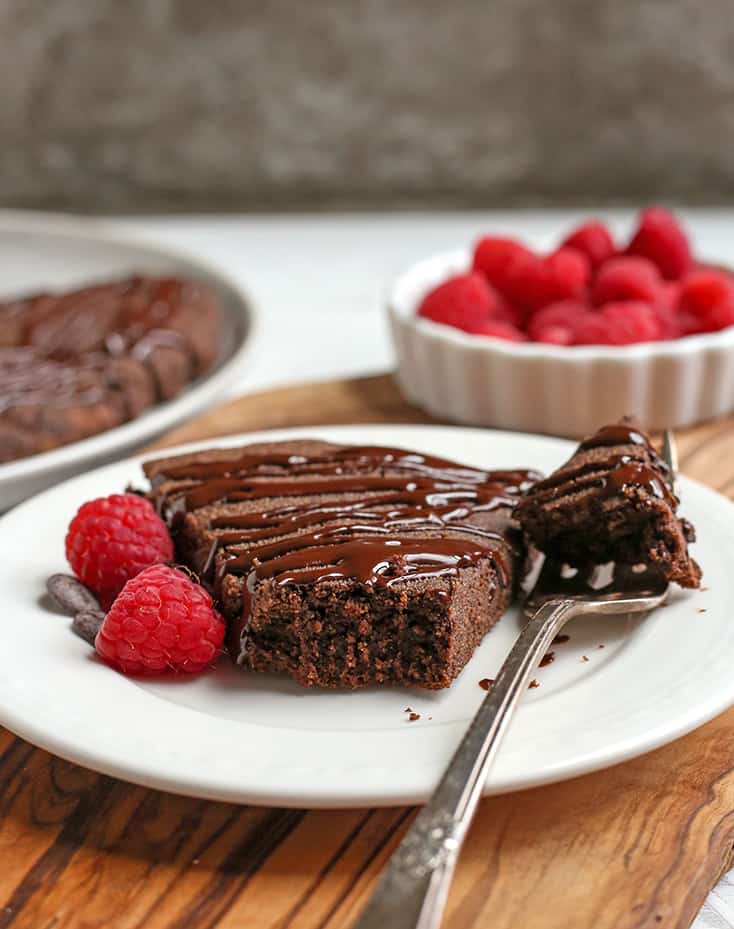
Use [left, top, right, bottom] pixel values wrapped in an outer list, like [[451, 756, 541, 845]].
[[0, 377, 734, 929]]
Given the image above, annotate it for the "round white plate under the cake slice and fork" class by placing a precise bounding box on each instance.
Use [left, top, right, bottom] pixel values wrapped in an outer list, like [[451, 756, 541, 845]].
[[0, 426, 734, 807]]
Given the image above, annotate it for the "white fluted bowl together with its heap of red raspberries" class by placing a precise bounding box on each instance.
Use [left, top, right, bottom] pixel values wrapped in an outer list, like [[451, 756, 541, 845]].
[[388, 207, 734, 436]]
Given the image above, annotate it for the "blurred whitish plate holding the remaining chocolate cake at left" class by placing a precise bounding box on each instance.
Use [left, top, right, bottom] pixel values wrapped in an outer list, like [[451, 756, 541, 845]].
[[0, 212, 254, 512]]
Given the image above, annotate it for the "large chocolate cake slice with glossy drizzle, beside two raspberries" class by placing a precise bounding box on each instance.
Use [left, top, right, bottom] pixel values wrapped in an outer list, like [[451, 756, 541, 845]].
[[145, 441, 538, 689]]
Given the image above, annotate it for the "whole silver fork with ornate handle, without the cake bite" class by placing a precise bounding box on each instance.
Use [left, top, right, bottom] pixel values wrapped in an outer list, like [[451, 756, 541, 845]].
[[352, 431, 677, 929]]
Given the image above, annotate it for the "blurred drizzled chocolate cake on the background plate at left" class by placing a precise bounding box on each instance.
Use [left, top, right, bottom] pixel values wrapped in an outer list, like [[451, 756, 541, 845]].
[[0, 277, 222, 463]]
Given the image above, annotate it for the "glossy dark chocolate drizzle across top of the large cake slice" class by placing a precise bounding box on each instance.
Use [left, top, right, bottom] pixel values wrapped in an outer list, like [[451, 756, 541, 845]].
[[149, 446, 538, 656]]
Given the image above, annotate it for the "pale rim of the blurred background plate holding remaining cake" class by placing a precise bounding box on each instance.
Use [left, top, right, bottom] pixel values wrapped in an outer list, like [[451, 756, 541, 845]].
[[0, 209, 261, 486]]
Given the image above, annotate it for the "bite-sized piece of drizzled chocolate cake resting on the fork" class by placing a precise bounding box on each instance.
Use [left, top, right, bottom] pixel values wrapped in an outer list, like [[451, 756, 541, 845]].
[[516, 420, 701, 587]]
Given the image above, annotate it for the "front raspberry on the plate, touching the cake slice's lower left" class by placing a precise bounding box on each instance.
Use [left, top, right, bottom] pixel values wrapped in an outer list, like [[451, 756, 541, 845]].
[[95, 565, 224, 674]]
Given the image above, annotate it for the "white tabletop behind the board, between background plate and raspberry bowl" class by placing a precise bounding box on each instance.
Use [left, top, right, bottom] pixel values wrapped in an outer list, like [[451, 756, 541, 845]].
[[109, 210, 734, 929]]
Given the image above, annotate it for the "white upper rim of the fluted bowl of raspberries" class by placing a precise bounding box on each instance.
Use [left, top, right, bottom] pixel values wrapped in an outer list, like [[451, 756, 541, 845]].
[[385, 248, 734, 364]]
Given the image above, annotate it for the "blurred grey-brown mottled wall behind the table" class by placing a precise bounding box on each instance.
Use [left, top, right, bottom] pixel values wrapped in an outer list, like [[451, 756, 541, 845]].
[[0, 0, 734, 212]]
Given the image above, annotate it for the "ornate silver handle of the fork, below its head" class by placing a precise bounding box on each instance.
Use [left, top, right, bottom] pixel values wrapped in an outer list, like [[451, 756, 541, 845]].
[[352, 600, 580, 929]]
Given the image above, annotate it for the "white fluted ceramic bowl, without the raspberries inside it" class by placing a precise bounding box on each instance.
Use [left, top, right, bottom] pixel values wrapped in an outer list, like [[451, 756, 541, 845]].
[[388, 249, 734, 437]]
